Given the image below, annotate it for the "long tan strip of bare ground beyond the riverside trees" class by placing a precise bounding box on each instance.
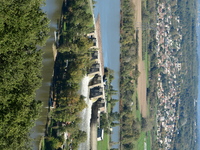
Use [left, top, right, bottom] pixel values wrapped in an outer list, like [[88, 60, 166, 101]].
[[133, 0, 147, 117]]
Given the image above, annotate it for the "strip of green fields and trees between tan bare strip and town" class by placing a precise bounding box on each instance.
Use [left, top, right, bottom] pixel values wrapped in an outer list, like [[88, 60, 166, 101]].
[[142, 0, 160, 149]]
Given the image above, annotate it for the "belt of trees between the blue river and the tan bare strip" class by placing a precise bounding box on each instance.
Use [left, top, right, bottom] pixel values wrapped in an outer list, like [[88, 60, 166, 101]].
[[120, 0, 141, 150]]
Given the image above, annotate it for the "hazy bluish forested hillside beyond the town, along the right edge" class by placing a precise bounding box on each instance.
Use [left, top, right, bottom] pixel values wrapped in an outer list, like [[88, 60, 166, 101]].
[[173, 0, 198, 150]]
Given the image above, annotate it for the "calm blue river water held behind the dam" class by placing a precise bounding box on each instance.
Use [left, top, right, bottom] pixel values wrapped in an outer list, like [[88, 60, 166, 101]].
[[94, 0, 120, 148]]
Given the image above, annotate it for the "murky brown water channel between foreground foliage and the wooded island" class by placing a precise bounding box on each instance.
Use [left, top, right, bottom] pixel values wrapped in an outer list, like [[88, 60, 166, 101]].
[[31, 0, 63, 150]]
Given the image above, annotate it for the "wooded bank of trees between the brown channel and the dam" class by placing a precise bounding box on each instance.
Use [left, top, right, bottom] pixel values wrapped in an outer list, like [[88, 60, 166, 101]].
[[44, 0, 94, 150]]
